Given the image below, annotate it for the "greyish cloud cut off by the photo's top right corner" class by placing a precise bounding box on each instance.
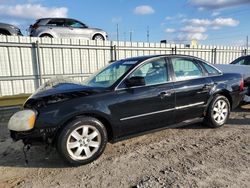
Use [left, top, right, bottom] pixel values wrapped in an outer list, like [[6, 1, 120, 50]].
[[188, 0, 250, 9]]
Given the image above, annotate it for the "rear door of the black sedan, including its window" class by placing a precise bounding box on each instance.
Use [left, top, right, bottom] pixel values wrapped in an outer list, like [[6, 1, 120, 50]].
[[170, 57, 213, 123]]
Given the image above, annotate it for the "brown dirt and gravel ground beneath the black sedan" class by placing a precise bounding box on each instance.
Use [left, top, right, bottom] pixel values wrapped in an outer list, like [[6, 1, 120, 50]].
[[0, 104, 250, 187]]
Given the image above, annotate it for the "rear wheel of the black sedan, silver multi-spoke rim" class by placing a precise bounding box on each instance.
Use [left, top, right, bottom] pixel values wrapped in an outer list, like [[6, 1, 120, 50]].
[[204, 95, 230, 128]]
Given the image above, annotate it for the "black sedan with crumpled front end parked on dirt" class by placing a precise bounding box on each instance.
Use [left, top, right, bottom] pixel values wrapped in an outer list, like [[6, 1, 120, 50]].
[[8, 55, 244, 164]]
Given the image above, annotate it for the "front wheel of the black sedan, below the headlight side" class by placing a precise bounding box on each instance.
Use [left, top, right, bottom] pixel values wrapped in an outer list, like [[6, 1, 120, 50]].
[[57, 117, 108, 165]]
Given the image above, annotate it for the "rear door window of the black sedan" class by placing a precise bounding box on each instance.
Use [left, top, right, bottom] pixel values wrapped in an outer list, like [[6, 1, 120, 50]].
[[172, 58, 203, 81]]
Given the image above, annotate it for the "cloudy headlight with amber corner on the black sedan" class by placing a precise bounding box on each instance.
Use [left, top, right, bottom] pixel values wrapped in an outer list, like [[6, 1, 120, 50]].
[[8, 110, 36, 131]]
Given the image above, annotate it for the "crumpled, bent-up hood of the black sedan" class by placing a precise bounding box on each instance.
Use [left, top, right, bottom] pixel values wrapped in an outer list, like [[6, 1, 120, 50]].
[[30, 78, 105, 99]]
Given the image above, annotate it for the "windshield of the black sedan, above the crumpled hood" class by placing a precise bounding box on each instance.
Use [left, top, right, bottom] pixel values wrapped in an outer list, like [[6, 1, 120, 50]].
[[84, 60, 137, 88]]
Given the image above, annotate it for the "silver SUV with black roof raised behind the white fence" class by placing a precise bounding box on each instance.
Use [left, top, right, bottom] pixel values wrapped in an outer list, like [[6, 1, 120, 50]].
[[30, 18, 108, 40]]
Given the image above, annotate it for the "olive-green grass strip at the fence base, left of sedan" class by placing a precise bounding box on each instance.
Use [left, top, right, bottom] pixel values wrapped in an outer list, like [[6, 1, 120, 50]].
[[0, 94, 30, 107]]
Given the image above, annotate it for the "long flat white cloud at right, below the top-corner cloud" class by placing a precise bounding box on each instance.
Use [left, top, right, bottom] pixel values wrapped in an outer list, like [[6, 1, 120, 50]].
[[184, 18, 240, 28]]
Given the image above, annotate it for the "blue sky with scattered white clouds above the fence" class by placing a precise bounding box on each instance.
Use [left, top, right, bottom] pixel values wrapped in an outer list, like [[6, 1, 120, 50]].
[[0, 0, 250, 46]]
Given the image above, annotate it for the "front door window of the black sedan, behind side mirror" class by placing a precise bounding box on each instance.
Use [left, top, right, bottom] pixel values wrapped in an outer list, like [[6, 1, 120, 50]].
[[128, 58, 169, 85]]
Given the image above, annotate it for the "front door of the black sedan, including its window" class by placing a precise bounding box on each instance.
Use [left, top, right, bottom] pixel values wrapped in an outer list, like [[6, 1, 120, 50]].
[[113, 58, 175, 137]]
